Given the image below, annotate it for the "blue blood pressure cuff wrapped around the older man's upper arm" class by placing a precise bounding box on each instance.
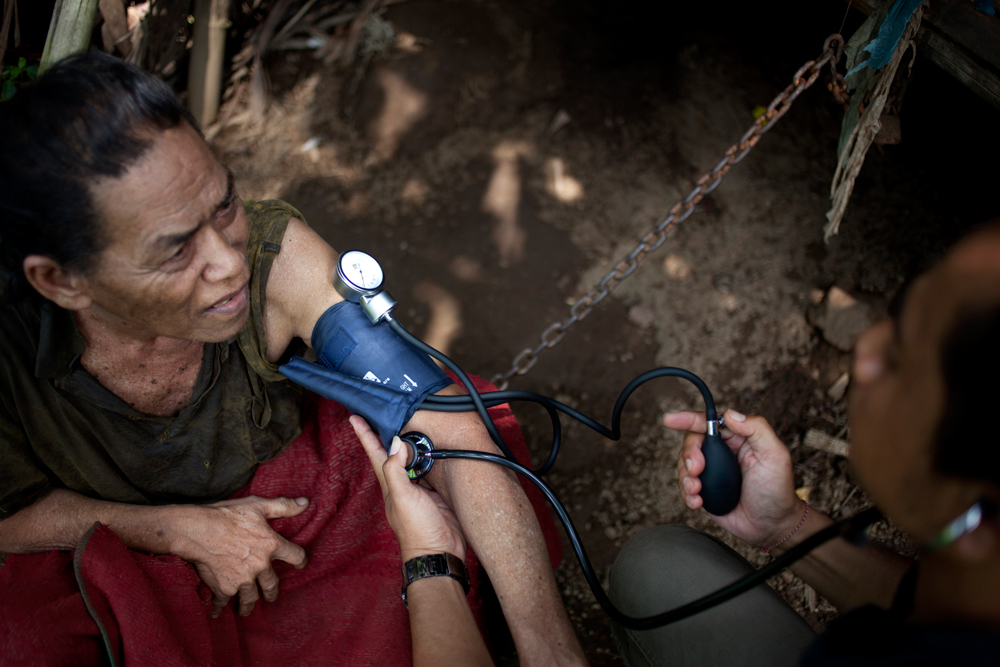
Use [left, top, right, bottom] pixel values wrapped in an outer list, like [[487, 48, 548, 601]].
[[278, 301, 452, 447]]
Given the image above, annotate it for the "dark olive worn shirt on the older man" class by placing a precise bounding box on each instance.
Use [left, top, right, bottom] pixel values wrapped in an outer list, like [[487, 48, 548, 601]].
[[0, 200, 302, 519]]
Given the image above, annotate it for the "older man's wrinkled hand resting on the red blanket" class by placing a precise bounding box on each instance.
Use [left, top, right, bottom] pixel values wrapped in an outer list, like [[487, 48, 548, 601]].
[[170, 496, 309, 618]]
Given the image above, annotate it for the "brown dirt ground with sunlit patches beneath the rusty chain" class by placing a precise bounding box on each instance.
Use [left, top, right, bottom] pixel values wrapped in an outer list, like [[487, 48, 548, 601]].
[[215, 0, 1000, 665]]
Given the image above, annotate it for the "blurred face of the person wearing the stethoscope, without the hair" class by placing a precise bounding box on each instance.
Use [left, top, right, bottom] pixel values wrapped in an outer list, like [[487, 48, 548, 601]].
[[850, 232, 1000, 540]]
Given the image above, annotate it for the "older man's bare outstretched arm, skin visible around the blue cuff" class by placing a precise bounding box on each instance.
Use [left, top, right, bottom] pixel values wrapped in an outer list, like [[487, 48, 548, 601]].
[[264, 219, 586, 665]]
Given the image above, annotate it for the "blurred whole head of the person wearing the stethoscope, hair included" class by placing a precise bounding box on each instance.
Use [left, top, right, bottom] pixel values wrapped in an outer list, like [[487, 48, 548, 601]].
[[851, 223, 1000, 556]]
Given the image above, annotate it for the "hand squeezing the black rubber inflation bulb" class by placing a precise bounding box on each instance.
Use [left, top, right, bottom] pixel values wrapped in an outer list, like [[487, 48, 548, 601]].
[[663, 410, 805, 547]]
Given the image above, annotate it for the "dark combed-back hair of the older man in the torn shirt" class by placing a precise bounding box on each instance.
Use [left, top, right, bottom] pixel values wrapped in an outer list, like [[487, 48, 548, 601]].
[[0, 52, 197, 301]]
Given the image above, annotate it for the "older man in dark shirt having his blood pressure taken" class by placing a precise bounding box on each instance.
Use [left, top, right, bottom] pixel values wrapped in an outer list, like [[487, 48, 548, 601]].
[[0, 55, 584, 665]]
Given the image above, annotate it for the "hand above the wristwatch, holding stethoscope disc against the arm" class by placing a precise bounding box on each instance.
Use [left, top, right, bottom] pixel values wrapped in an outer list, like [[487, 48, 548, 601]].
[[351, 415, 465, 563]]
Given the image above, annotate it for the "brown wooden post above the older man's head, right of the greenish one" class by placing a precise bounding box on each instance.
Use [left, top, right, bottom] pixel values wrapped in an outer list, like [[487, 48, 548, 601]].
[[188, 0, 229, 129]]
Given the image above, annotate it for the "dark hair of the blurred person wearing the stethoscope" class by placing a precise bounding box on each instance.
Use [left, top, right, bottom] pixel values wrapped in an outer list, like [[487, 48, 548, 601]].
[[935, 306, 1000, 486]]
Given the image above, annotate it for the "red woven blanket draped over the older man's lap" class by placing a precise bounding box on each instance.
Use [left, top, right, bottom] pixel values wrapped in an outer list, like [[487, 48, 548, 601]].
[[0, 382, 562, 667]]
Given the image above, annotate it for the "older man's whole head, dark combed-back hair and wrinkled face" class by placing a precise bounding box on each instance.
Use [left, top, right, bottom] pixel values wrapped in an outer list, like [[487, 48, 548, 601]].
[[0, 53, 249, 341]]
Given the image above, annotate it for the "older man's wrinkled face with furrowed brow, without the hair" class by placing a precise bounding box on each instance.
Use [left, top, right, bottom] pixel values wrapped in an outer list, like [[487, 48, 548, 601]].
[[79, 123, 250, 342]]
